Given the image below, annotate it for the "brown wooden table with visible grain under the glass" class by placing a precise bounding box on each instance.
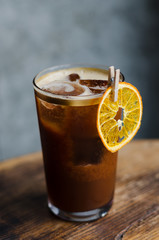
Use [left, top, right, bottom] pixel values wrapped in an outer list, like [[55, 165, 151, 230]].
[[0, 140, 159, 240]]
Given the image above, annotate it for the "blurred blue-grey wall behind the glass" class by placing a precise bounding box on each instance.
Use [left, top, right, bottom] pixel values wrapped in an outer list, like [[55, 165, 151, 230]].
[[0, 0, 159, 160]]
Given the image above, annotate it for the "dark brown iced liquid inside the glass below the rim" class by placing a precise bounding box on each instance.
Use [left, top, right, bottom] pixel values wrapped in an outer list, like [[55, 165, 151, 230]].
[[37, 99, 117, 212]]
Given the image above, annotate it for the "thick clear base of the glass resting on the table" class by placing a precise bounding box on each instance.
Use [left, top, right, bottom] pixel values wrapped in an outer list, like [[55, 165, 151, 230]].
[[48, 201, 112, 222]]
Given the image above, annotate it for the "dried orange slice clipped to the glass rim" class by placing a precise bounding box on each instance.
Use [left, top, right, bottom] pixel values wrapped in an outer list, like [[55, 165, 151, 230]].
[[97, 82, 143, 152]]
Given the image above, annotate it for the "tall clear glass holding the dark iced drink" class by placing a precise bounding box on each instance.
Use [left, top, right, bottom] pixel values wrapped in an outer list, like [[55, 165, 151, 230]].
[[33, 65, 124, 221]]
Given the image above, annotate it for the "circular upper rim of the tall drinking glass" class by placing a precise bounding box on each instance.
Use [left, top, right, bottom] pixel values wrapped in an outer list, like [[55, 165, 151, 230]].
[[33, 63, 125, 106]]
